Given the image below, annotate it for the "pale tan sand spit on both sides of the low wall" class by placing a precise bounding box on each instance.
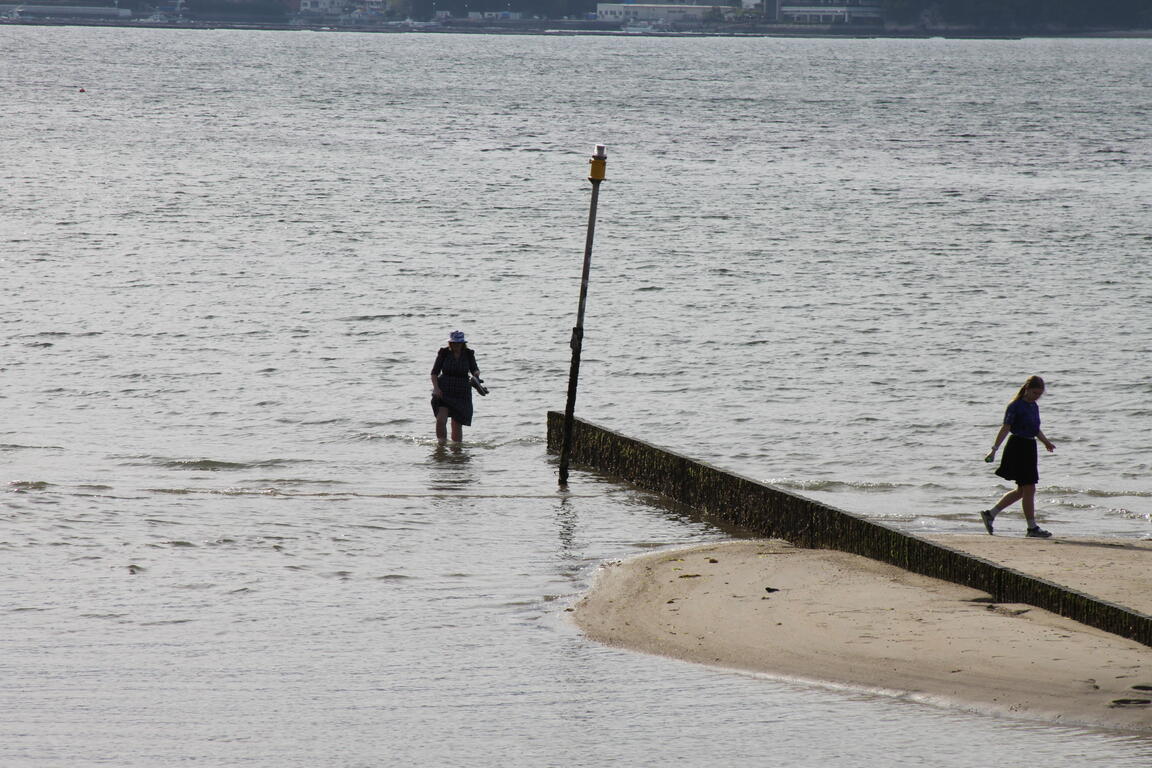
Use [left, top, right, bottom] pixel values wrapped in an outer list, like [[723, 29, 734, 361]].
[[571, 535, 1152, 732]]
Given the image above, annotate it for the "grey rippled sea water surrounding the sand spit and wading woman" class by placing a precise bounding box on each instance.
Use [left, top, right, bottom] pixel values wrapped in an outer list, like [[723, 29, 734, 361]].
[[0, 28, 1152, 768]]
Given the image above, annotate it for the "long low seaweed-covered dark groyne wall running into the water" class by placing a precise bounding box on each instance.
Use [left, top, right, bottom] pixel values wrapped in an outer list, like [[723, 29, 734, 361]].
[[548, 411, 1152, 646]]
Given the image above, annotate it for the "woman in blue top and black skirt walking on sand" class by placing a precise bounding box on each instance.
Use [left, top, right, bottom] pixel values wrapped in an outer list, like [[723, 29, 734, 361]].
[[980, 377, 1056, 539]]
